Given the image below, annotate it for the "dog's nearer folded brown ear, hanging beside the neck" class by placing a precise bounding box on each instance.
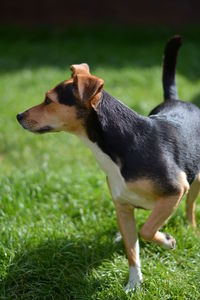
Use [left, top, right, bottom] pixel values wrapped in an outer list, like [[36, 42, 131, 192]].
[[74, 74, 104, 109]]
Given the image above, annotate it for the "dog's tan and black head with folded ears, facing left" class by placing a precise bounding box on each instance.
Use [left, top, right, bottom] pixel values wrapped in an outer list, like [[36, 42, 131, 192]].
[[17, 64, 104, 134]]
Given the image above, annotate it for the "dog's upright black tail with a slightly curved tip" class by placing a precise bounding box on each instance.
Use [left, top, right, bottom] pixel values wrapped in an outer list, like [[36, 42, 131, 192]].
[[162, 35, 182, 101]]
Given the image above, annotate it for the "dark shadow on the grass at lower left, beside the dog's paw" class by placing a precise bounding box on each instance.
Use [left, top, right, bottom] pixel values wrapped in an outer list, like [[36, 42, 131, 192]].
[[1, 232, 125, 299]]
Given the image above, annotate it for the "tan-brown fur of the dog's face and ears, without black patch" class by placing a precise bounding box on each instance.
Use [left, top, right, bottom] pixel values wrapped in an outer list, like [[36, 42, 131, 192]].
[[20, 64, 103, 136]]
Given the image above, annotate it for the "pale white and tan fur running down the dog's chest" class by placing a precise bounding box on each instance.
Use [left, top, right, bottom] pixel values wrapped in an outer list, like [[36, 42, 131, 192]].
[[81, 137, 155, 209]]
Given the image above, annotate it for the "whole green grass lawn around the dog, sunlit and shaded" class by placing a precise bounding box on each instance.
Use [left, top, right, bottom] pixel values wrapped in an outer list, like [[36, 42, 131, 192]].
[[0, 26, 200, 300]]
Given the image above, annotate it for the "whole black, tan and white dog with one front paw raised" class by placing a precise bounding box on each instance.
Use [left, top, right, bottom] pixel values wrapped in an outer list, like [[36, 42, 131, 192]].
[[17, 37, 200, 290]]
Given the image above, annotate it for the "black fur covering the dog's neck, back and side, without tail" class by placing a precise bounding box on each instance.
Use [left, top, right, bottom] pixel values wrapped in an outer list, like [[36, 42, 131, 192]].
[[85, 91, 200, 194]]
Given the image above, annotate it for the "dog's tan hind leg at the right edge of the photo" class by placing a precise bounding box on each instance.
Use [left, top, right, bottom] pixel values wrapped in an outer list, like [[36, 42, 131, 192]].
[[186, 174, 200, 228]]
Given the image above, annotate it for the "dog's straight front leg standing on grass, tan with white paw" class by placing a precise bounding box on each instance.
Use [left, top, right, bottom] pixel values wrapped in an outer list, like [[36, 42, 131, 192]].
[[115, 202, 142, 291]]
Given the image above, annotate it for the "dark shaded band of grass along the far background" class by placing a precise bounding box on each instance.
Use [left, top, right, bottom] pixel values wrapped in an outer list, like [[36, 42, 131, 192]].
[[0, 26, 200, 80]]
